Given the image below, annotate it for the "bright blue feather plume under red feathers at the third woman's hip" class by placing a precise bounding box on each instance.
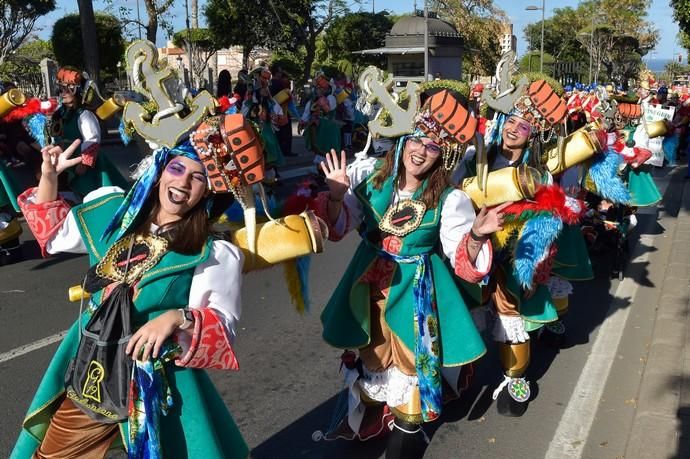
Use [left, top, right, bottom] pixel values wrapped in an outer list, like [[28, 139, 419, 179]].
[[513, 216, 563, 288]]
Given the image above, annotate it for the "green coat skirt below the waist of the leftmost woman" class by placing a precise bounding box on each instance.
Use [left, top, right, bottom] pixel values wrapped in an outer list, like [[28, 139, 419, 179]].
[[10, 323, 249, 459]]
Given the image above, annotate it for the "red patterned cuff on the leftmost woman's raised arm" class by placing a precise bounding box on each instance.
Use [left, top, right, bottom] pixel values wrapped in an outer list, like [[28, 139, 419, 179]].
[[17, 188, 70, 257]]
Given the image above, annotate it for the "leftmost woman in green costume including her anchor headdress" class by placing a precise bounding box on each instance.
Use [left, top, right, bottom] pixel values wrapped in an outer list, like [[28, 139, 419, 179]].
[[11, 41, 263, 459]]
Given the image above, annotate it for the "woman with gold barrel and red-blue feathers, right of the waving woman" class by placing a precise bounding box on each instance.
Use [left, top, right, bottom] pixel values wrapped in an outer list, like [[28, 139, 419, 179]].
[[454, 60, 618, 416]]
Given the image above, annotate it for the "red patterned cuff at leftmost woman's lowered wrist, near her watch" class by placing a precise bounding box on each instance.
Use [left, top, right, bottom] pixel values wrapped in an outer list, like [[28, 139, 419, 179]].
[[175, 308, 240, 370]]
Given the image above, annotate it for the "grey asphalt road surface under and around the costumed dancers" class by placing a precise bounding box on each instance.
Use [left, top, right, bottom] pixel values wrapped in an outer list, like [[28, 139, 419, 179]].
[[0, 170, 667, 459]]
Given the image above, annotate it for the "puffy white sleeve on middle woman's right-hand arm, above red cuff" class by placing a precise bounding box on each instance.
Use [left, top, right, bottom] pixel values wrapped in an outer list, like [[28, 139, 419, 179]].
[[440, 189, 491, 274]]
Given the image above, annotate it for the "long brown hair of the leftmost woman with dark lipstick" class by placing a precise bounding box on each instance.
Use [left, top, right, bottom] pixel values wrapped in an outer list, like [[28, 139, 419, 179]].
[[137, 186, 210, 255]]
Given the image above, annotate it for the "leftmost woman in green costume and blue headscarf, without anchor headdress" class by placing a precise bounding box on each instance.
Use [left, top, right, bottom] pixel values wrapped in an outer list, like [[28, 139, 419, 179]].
[[11, 135, 248, 459]]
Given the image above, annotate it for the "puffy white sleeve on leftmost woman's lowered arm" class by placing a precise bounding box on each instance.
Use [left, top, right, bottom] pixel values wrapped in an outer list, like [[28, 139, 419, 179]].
[[189, 241, 244, 343]]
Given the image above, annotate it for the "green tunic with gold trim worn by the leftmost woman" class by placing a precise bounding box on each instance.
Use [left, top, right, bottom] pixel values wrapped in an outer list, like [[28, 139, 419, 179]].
[[11, 193, 248, 459]]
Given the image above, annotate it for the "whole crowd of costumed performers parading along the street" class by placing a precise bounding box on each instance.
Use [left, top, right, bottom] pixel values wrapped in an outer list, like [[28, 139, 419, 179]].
[[0, 41, 680, 459]]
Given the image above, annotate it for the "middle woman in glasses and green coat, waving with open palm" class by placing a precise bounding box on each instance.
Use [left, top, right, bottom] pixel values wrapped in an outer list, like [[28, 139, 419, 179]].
[[316, 68, 502, 458]]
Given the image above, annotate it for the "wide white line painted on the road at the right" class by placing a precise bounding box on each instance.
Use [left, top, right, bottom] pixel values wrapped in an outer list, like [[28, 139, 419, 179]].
[[544, 235, 654, 459]]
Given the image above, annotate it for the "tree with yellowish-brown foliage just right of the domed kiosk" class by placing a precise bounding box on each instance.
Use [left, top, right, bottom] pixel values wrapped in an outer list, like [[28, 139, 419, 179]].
[[432, 0, 509, 75]]
